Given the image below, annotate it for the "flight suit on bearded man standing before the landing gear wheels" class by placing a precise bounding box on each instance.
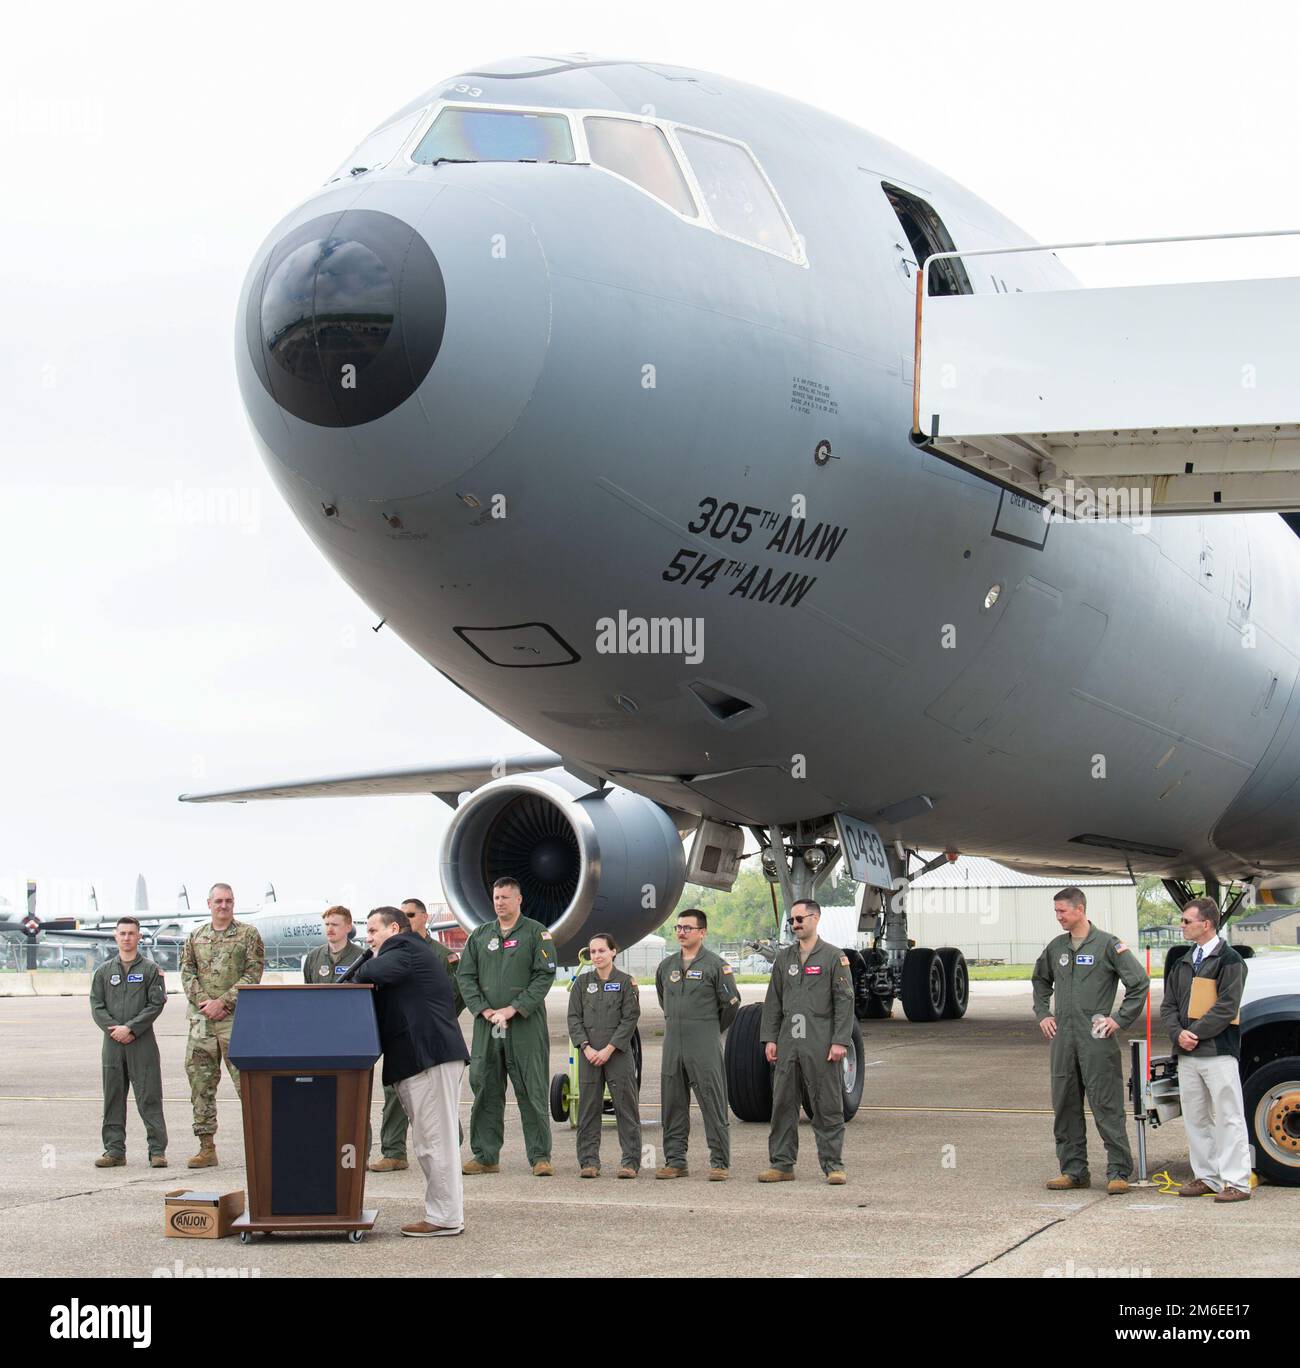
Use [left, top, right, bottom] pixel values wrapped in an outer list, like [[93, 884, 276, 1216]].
[[762, 938, 853, 1174]]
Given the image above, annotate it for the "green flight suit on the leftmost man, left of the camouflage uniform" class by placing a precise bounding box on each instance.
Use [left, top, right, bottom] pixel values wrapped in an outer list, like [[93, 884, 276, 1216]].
[[90, 953, 167, 1159]]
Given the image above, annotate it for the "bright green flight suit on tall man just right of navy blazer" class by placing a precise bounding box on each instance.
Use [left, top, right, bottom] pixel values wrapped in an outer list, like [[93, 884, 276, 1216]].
[[458, 917, 556, 1164]]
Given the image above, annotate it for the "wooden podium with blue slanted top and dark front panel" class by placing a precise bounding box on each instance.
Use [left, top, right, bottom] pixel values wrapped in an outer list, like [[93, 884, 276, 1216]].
[[230, 984, 379, 1244]]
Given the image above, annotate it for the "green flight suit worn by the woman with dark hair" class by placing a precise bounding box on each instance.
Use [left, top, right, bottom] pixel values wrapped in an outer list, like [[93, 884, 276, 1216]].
[[569, 969, 640, 1171]]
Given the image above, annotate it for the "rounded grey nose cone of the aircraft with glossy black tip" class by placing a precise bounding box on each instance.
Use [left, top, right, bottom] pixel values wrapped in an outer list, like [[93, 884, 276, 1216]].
[[237, 183, 550, 499]]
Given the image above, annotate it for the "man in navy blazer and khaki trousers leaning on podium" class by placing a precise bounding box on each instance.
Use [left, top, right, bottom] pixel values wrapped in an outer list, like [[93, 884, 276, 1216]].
[[350, 907, 469, 1235]]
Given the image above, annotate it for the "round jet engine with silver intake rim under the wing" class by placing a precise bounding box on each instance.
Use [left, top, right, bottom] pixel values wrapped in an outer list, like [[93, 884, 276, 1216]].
[[441, 769, 686, 964]]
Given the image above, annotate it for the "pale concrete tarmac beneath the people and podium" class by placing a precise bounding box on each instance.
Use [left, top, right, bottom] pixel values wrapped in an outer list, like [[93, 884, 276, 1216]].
[[0, 984, 1300, 1279]]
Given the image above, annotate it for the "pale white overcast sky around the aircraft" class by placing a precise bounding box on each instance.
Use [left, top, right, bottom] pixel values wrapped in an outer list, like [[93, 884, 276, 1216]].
[[0, 0, 1300, 914]]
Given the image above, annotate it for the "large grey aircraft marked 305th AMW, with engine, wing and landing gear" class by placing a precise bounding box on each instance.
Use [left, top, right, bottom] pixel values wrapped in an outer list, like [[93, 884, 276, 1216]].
[[185, 57, 1300, 1119]]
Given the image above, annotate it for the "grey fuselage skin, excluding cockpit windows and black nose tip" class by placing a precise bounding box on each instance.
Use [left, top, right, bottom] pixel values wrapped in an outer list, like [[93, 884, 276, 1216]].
[[235, 59, 1300, 877]]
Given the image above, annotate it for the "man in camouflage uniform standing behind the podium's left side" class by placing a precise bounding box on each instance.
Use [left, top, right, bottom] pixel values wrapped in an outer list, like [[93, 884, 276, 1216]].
[[181, 884, 267, 1168]]
